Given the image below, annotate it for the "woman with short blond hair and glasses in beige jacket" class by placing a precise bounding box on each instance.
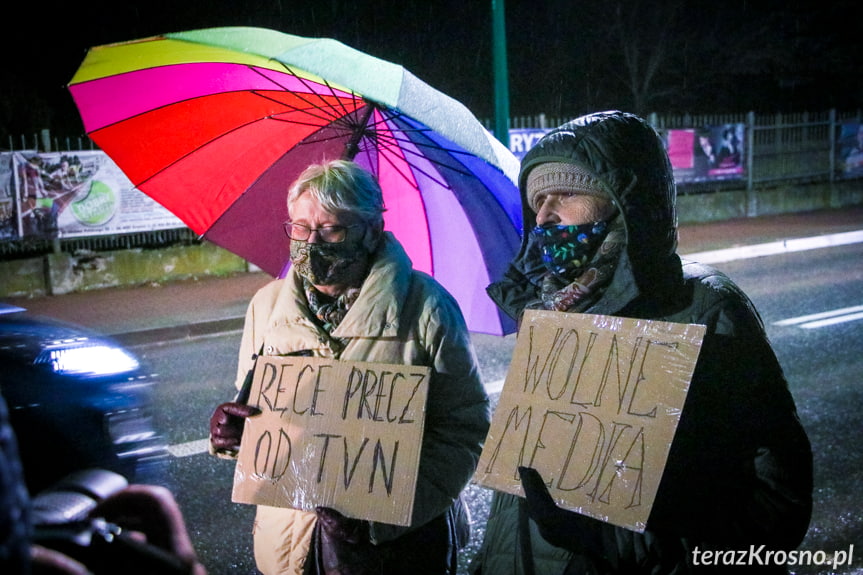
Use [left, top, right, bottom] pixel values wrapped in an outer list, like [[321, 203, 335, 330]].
[[210, 160, 490, 575]]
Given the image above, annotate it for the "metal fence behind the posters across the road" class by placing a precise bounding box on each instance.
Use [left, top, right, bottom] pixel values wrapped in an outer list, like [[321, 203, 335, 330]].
[[0, 110, 863, 259]]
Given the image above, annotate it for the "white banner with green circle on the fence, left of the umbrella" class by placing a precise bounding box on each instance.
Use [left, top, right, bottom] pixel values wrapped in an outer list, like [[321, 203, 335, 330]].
[[9, 151, 185, 238]]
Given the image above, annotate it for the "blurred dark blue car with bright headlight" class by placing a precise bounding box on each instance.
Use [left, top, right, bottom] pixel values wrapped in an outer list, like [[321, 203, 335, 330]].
[[0, 303, 167, 493]]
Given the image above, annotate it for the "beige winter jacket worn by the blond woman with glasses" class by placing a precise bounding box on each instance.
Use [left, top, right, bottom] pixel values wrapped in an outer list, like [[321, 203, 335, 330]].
[[226, 233, 489, 575]]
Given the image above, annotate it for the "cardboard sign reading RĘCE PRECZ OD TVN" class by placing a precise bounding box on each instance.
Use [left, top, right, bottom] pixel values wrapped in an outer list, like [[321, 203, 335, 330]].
[[233, 356, 430, 525]]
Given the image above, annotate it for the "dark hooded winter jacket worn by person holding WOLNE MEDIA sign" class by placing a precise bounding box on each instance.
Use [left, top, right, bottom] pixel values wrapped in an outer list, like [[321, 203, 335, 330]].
[[472, 112, 812, 575]]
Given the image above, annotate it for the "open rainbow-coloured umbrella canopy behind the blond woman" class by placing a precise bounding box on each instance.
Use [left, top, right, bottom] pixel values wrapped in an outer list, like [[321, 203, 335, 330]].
[[69, 27, 521, 334]]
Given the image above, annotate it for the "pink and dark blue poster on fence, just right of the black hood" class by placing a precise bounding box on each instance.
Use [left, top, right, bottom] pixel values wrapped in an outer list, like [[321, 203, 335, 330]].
[[664, 124, 745, 183]]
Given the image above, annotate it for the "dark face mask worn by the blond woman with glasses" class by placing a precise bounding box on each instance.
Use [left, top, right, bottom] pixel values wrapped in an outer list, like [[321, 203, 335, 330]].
[[291, 238, 371, 287]]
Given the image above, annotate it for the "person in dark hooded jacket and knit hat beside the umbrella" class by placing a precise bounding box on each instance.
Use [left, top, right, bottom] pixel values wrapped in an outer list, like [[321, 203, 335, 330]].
[[471, 111, 812, 575]]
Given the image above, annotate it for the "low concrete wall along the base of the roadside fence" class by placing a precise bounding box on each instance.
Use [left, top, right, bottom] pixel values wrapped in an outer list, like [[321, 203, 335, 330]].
[[0, 179, 863, 297]]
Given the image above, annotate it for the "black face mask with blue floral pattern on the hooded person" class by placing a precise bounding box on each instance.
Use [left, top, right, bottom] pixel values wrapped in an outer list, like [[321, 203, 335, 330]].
[[531, 222, 608, 280]]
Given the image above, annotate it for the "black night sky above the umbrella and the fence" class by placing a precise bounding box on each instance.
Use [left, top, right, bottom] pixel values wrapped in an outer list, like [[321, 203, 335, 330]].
[[0, 0, 861, 138]]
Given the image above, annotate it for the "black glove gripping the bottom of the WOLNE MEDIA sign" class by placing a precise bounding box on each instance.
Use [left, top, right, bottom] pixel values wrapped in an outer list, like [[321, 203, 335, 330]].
[[518, 467, 607, 564]]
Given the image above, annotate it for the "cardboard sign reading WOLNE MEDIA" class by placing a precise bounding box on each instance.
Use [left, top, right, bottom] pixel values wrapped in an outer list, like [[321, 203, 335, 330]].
[[474, 310, 705, 532]]
